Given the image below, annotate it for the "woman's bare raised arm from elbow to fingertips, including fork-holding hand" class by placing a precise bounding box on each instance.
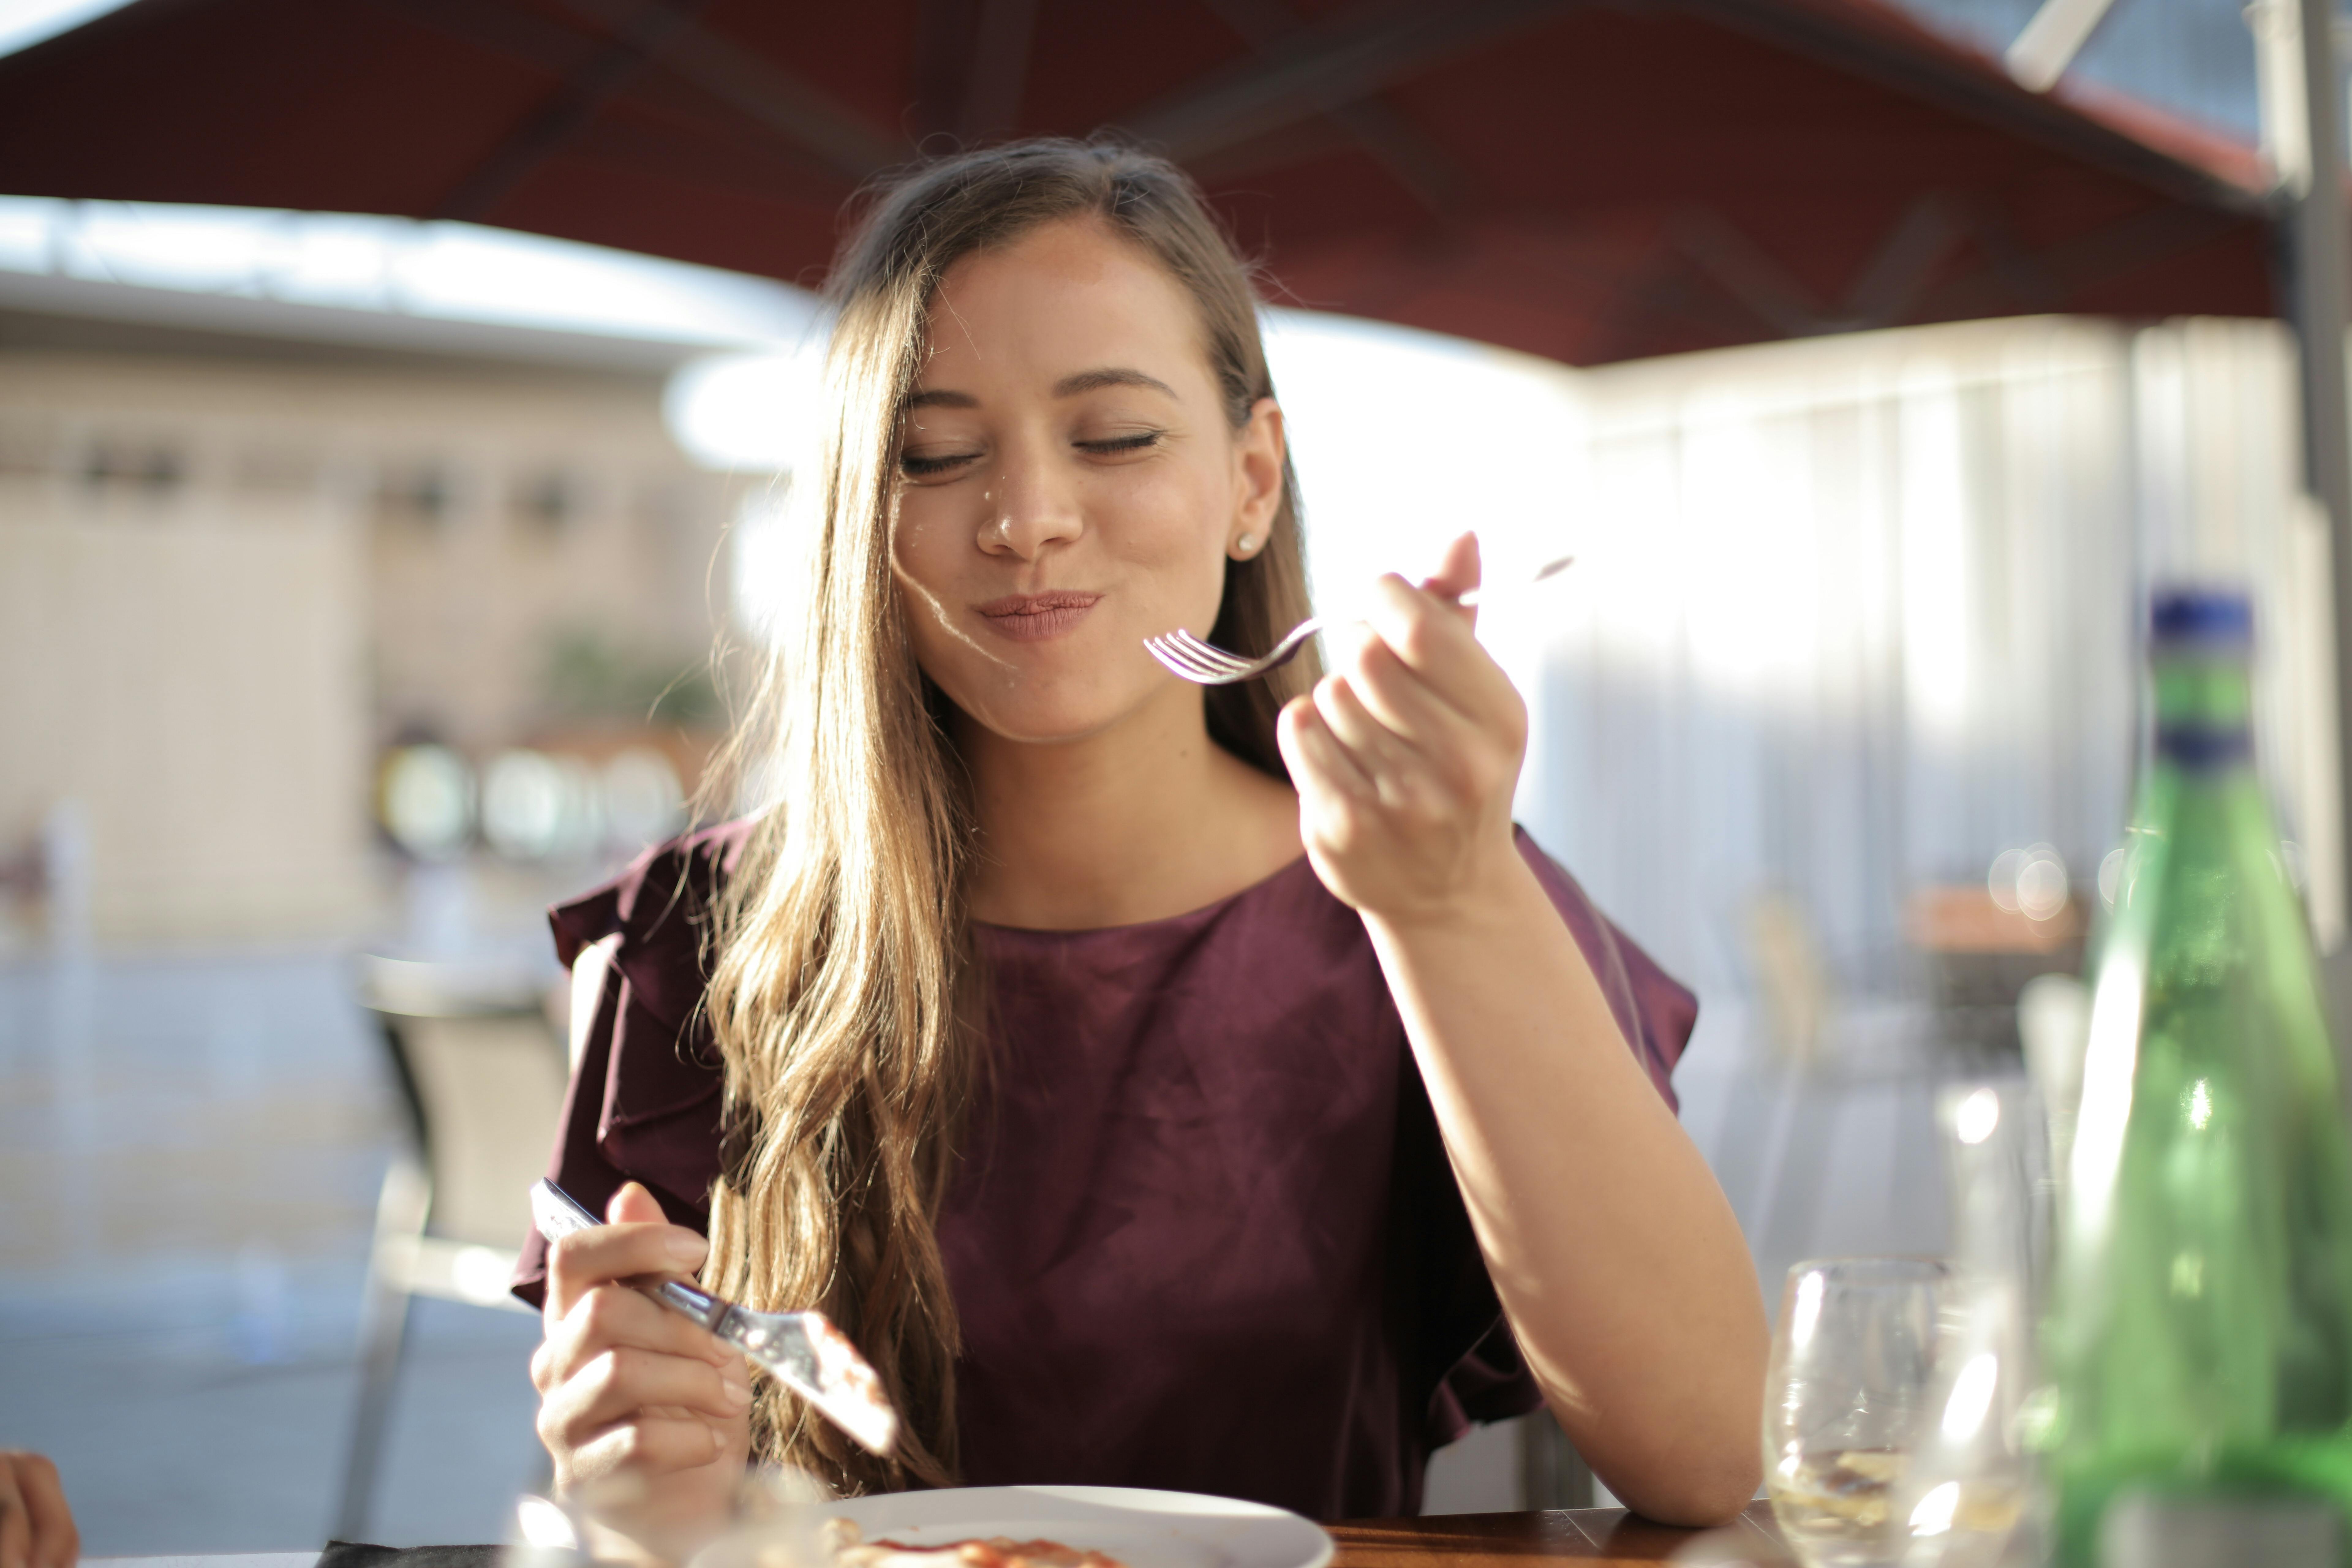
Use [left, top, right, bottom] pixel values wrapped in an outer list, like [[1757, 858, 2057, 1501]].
[[1282, 541, 1766, 1523]]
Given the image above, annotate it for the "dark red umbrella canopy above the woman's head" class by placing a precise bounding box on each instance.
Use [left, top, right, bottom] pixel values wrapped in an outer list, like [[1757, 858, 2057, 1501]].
[[0, 0, 2272, 364]]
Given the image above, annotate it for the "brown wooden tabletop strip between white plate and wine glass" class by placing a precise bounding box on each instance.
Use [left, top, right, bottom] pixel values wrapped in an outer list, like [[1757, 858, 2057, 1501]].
[[1331, 1502, 1790, 1568]]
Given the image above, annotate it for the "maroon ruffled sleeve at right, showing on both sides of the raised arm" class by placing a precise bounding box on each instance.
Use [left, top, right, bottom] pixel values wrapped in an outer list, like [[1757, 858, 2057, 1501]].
[[1395, 830, 1698, 1448]]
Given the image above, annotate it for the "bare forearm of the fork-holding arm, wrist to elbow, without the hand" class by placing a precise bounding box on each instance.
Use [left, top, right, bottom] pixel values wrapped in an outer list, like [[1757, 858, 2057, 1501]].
[[1364, 853, 1766, 1521]]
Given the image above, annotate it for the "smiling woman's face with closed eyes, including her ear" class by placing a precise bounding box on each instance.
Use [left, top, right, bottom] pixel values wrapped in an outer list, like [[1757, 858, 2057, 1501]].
[[891, 221, 1282, 741]]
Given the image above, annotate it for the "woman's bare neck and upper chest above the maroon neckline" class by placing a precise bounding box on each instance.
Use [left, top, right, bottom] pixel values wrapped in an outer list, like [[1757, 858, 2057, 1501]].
[[957, 686, 1298, 931]]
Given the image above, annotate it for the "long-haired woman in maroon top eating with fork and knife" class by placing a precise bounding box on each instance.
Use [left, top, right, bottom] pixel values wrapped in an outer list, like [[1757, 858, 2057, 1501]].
[[518, 141, 1764, 1537]]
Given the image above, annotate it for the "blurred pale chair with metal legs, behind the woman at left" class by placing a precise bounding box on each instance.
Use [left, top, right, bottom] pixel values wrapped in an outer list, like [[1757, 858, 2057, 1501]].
[[334, 957, 567, 1540]]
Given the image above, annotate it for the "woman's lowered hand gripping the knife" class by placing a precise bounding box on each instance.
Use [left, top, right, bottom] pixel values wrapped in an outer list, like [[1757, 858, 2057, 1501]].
[[532, 1182, 750, 1561]]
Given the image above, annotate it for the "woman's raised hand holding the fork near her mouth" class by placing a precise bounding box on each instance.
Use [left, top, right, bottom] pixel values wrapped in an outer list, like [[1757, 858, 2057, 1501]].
[[1277, 533, 1526, 924]]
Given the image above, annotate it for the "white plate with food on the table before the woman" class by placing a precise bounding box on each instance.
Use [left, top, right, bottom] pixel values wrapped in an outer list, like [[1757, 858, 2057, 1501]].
[[819, 1486, 1331, 1568]]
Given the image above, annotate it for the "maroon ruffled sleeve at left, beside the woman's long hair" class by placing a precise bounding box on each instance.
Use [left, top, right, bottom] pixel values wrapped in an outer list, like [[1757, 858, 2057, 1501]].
[[513, 823, 750, 1307]]
